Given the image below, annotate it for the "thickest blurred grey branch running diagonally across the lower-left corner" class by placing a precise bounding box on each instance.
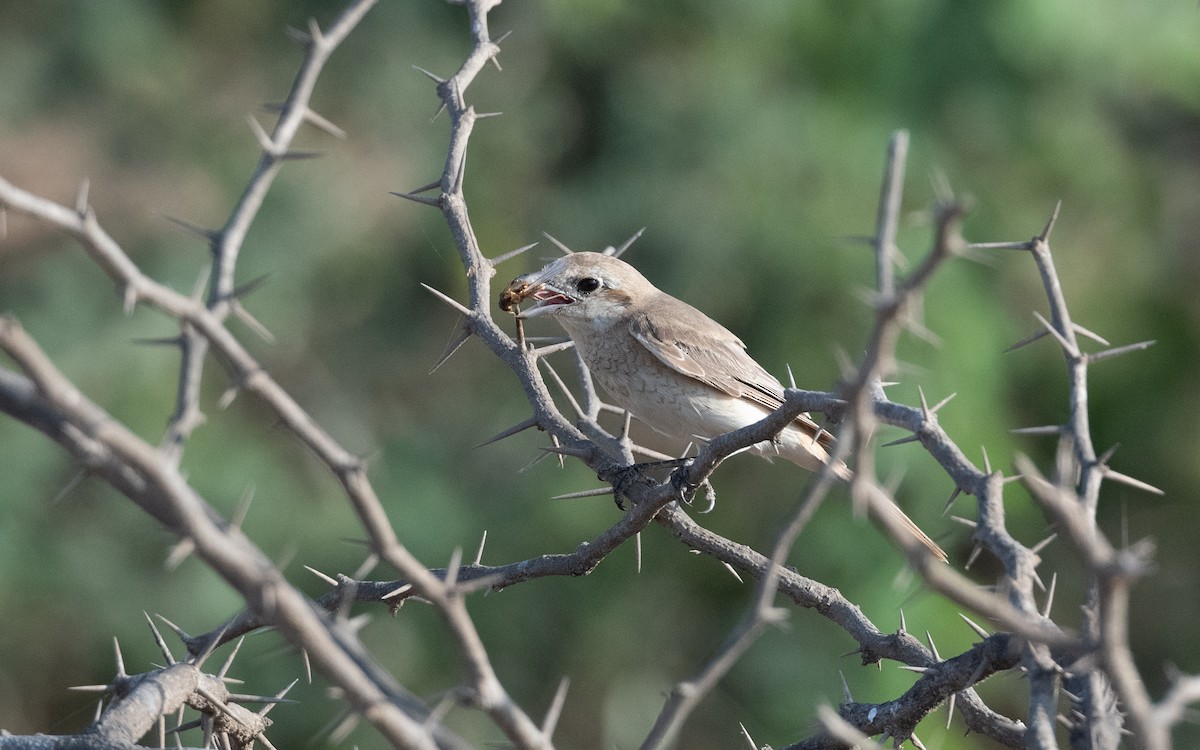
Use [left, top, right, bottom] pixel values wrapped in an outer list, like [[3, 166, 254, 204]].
[[0, 318, 462, 748]]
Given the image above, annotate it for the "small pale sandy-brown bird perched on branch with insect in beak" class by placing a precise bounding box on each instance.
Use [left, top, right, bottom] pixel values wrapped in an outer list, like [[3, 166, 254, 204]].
[[499, 252, 947, 562]]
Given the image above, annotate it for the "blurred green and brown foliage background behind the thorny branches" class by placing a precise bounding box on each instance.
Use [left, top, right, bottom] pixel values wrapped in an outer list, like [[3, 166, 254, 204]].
[[0, 0, 1200, 749]]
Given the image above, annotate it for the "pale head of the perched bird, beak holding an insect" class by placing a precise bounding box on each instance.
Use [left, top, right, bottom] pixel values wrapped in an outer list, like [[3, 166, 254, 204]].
[[500, 252, 655, 323]]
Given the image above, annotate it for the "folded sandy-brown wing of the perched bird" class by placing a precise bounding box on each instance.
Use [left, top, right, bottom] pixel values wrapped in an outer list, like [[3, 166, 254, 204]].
[[629, 298, 833, 448]]
